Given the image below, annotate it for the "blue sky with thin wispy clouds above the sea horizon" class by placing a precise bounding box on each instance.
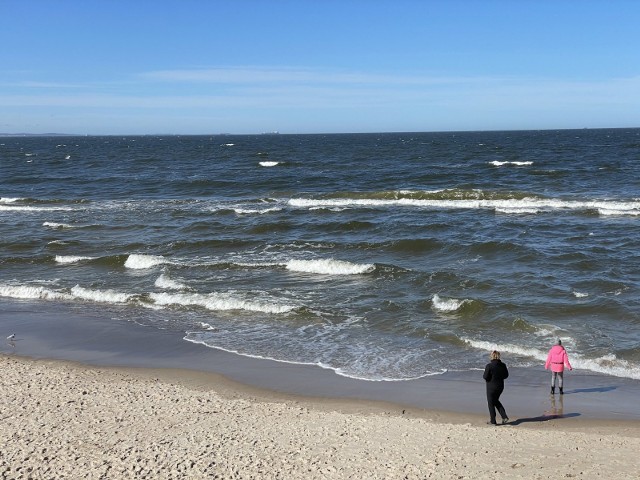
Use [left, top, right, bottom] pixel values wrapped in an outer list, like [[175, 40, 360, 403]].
[[0, 0, 640, 134]]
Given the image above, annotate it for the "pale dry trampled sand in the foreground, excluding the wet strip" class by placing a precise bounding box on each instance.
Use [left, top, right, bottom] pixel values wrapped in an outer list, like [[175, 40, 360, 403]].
[[0, 356, 640, 479]]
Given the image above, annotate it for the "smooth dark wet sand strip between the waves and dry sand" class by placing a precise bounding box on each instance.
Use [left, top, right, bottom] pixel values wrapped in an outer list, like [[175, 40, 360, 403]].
[[0, 302, 640, 423]]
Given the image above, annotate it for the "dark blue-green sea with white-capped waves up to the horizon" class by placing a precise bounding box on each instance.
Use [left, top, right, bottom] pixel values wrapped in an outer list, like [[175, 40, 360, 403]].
[[0, 129, 640, 380]]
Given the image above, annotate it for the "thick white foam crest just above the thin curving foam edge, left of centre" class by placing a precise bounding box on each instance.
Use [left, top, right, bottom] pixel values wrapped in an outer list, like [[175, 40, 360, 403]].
[[149, 293, 296, 313]]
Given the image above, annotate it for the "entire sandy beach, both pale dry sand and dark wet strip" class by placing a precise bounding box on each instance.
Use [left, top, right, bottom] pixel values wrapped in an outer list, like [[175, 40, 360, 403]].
[[0, 304, 640, 479]]
